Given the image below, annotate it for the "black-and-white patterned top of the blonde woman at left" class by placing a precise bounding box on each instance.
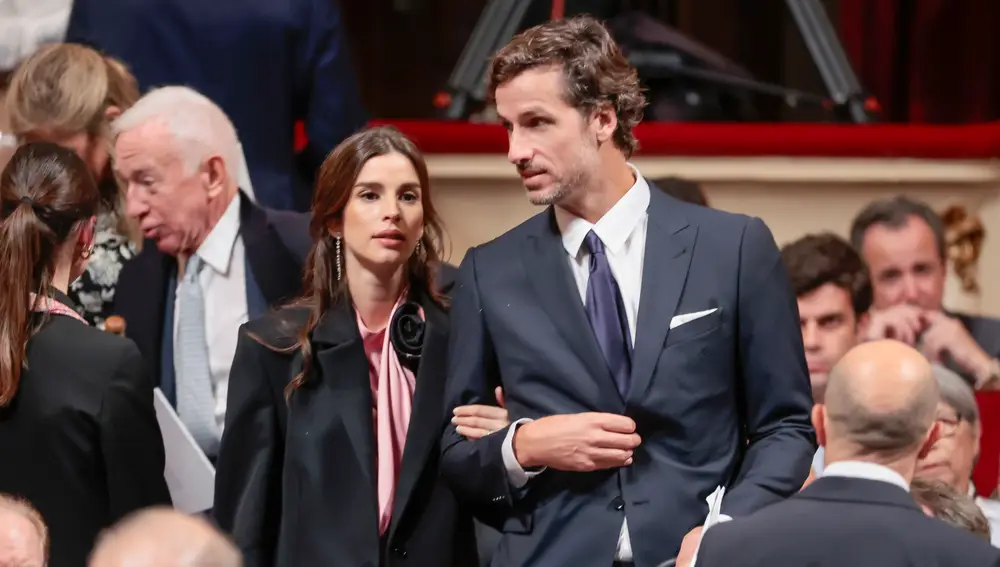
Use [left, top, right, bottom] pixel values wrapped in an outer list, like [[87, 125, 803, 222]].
[[69, 214, 137, 329]]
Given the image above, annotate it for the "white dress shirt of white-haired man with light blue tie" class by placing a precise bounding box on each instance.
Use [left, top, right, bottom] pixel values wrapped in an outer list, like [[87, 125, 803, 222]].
[[174, 194, 249, 432]]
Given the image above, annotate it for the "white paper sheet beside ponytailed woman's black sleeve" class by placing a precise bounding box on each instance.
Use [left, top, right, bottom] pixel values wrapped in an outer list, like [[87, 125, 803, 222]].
[[153, 388, 215, 514]]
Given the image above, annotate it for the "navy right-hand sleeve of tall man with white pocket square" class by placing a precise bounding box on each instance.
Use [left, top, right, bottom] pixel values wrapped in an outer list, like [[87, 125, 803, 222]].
[[722, 218, 816, 517]]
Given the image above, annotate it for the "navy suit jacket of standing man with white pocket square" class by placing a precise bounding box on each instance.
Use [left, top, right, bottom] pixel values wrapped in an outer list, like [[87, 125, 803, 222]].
[[441, 188, 816, 567]]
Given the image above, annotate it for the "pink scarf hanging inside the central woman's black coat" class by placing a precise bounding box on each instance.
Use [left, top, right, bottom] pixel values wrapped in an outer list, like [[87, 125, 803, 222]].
[[358, 293, 422, 534]]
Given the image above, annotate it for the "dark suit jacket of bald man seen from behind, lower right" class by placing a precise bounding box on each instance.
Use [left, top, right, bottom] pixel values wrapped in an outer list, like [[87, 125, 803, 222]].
[[698, 477, 1000, 567]]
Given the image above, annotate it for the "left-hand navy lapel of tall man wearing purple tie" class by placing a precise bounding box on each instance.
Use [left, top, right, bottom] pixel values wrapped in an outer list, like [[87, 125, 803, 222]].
[[522, 212, 614, 389]]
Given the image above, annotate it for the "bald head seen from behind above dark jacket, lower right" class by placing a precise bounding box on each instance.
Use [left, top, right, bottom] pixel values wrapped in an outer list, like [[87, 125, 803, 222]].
[[825, 340, 938, 459]]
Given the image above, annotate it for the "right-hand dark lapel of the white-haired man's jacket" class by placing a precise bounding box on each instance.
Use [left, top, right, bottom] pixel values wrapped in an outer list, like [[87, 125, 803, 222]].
[[240, 194, 302, 307]]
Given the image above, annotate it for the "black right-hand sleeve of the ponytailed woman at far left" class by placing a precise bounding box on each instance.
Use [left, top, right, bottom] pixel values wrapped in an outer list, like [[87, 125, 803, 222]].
[[98, 341, 171, 519]]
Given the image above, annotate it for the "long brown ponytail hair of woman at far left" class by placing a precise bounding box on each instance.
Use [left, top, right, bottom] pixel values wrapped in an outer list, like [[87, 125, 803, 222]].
[[0, 142, 101, 407]]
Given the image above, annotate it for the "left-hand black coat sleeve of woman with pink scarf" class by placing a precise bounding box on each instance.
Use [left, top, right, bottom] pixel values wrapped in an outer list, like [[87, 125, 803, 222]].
[[213, 326, 284, 567]]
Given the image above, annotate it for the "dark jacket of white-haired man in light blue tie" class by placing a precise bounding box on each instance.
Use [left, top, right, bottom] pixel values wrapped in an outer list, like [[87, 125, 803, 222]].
[[113, 197, 312, 394]]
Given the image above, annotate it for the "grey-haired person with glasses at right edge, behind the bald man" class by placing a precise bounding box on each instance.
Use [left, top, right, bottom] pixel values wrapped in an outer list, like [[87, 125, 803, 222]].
[[916, 365, 1000, 547]]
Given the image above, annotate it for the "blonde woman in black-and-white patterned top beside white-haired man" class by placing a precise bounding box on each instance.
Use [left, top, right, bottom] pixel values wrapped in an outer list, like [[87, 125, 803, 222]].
[[6, 43, 139, 327]]
